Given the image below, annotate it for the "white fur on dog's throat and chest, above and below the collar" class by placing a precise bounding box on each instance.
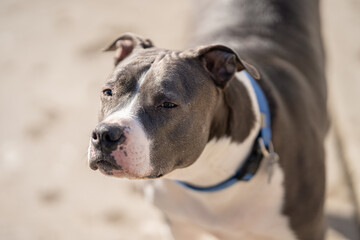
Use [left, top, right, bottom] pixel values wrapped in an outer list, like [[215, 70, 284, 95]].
[[148, 73, 296, 240]]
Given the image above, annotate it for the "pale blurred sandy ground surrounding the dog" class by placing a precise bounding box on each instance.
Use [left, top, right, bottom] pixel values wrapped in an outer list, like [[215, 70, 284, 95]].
[[0, 0, 360, 240]]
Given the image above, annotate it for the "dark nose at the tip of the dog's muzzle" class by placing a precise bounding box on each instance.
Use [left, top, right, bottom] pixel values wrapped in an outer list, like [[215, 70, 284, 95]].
[[91, 123, 126, 150]]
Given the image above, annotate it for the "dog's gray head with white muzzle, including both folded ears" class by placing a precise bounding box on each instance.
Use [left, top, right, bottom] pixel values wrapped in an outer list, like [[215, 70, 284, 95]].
[[89, 34, 258, 178]]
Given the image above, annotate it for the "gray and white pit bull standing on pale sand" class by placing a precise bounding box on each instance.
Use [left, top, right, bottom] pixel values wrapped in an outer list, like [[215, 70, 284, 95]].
[[89, 0, 328, 240]]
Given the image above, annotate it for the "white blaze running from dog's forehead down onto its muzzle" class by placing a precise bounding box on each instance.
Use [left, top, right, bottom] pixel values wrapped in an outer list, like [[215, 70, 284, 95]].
[[95, 71, 153, 178]]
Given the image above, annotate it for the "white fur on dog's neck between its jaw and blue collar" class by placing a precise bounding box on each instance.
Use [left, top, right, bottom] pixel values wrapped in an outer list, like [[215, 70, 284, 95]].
[[165, 72, 261, 186]]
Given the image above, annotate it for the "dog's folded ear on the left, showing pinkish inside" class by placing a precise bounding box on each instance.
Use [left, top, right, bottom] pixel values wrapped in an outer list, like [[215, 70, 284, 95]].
[[103, 33, 153, 66]]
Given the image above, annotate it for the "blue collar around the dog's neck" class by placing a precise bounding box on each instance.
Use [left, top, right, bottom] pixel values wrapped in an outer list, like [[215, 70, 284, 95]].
[[175, 70, 272, 192]]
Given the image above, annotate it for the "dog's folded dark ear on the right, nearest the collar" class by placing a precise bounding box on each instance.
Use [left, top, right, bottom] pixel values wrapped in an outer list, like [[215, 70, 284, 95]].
[[196, 45, 260, 88]]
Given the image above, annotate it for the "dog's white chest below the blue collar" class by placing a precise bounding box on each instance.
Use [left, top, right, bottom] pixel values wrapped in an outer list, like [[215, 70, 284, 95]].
[[149, 164, 296, 240]]
